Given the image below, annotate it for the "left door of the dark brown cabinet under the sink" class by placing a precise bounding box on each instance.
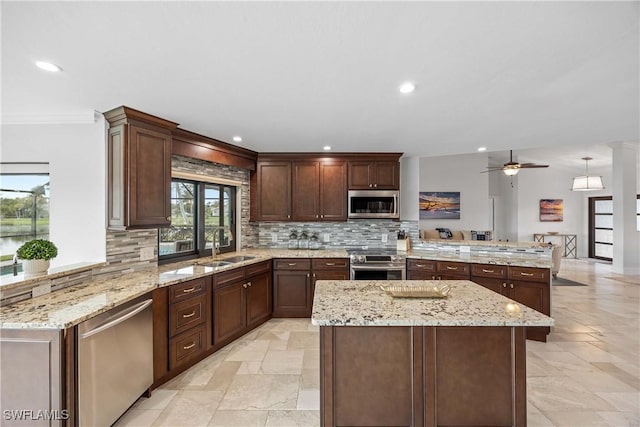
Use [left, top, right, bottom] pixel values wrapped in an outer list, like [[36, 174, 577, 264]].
[[213, 281, 247, 345]]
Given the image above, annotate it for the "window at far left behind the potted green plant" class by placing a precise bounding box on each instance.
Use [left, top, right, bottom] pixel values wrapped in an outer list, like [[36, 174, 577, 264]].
[[0, 173, 49, 274]]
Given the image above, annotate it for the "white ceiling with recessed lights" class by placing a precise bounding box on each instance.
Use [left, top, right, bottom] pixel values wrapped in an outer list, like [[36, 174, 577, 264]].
[[0, 1, 640, 167]]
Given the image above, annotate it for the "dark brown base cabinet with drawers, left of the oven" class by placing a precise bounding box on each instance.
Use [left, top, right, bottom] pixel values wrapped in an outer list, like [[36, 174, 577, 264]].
[[273, 258, 349, 317]]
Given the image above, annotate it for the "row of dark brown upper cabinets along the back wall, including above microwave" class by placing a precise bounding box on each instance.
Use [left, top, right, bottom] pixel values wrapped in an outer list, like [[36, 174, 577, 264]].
[[251, 153, 401, 221]]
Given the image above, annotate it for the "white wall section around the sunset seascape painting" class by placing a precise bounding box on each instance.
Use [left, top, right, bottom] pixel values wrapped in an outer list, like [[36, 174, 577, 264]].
[[420, 153, 490, 230]]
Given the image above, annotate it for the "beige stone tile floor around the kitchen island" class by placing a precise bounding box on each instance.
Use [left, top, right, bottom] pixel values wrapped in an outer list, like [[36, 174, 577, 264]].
[[116, 259, 640, 427]]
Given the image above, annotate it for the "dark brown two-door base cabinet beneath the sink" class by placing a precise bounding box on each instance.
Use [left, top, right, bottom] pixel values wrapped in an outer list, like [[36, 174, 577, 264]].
[[213, 261, 272, 347]]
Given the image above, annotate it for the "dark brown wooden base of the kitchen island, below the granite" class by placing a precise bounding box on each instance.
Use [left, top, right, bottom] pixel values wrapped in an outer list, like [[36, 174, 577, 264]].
[[320, 326, 527, 427]]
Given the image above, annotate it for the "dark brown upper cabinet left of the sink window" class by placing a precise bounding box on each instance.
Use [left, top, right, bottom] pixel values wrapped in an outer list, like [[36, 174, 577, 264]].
[[105, 107, 177, 230]]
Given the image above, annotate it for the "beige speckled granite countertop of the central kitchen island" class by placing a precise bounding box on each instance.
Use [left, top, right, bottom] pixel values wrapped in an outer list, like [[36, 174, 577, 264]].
[[311, 280, 554, 326]]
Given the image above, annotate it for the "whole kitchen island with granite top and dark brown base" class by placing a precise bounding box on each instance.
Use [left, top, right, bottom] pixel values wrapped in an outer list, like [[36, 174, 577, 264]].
[[312, 280, 553, 427]]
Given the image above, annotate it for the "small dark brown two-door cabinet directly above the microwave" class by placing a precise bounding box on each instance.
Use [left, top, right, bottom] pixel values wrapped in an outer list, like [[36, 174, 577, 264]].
[[349, 161, 400, 190]]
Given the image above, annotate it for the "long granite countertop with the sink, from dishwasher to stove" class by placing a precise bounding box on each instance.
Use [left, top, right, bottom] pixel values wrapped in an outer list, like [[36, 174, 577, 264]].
[[0, 249, 347, 329]]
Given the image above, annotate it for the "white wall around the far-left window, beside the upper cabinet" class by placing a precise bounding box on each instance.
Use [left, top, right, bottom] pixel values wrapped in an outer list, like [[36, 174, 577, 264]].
[[1, 117, 106, 267]]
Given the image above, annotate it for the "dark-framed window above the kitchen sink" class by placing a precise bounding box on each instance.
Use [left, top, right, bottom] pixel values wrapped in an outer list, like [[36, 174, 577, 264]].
[[158, 179, 236, 260]]
